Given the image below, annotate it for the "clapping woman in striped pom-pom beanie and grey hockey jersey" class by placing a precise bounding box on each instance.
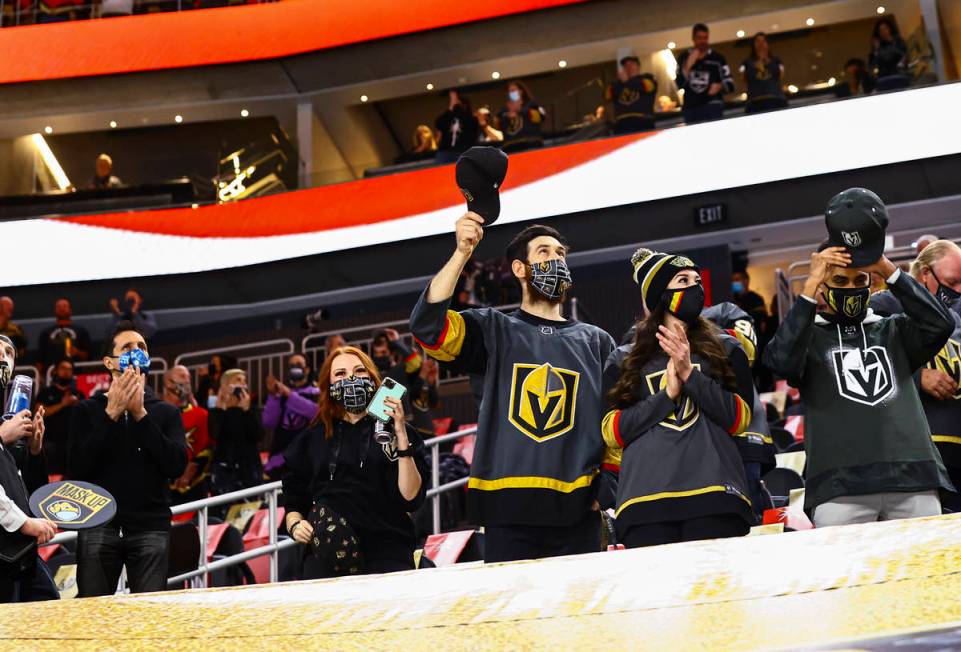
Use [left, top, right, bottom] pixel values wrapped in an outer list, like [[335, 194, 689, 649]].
[[602, 249, 754, 548]]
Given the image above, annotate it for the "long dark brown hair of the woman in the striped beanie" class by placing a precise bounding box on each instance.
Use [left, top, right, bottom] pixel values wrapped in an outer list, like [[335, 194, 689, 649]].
[[607, 305, 737, 409]]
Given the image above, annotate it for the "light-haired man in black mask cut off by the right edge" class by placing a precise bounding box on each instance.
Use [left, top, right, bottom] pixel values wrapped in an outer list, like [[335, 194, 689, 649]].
[[871, 240, 961, 512]]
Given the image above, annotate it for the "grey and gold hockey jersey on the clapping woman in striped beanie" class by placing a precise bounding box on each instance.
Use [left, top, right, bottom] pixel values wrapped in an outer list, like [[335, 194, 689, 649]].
[[602, 334, 754, 535]]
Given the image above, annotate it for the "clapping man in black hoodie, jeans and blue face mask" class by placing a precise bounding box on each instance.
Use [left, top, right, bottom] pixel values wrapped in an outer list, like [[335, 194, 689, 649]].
[[67, 322, 187, 597]]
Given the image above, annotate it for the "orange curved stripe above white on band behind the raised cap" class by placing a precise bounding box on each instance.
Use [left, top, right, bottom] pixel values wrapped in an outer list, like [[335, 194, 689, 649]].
[[58, 132, 653, 238]]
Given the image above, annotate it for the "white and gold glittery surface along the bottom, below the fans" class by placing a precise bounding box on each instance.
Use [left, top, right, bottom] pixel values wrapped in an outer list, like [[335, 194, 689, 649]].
[[0, 515, 961, 652]]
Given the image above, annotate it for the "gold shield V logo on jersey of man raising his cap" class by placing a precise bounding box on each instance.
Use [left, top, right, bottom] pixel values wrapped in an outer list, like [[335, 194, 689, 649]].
[[508, 363, 580, 443]]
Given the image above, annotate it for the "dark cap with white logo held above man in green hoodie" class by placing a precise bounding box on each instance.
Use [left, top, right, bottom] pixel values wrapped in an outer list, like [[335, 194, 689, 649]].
[[822, 188, 889, 267]]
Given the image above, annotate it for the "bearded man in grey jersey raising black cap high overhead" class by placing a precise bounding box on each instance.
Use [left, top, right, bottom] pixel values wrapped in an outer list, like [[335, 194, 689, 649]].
[[410, 147, 617, 562]]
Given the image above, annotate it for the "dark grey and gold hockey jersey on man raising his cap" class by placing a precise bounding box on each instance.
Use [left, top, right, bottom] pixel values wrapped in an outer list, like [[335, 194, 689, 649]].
[[410, 292, 619, 526]]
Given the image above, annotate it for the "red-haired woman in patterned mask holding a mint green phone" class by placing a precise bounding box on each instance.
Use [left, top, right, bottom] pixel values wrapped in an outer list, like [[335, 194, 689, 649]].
[[283, 346, 428, 579]]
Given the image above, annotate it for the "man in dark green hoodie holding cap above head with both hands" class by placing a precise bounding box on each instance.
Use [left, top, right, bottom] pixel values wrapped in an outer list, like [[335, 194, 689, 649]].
[[764, 188, 953, 527]]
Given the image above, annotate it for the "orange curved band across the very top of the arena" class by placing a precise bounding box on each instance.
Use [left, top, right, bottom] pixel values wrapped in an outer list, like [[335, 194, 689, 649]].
[[0, 0, 585, 84]]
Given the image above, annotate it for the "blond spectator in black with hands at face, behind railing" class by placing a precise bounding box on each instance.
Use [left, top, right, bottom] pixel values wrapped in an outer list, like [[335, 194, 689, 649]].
[[209, 369, 264, 494]]
